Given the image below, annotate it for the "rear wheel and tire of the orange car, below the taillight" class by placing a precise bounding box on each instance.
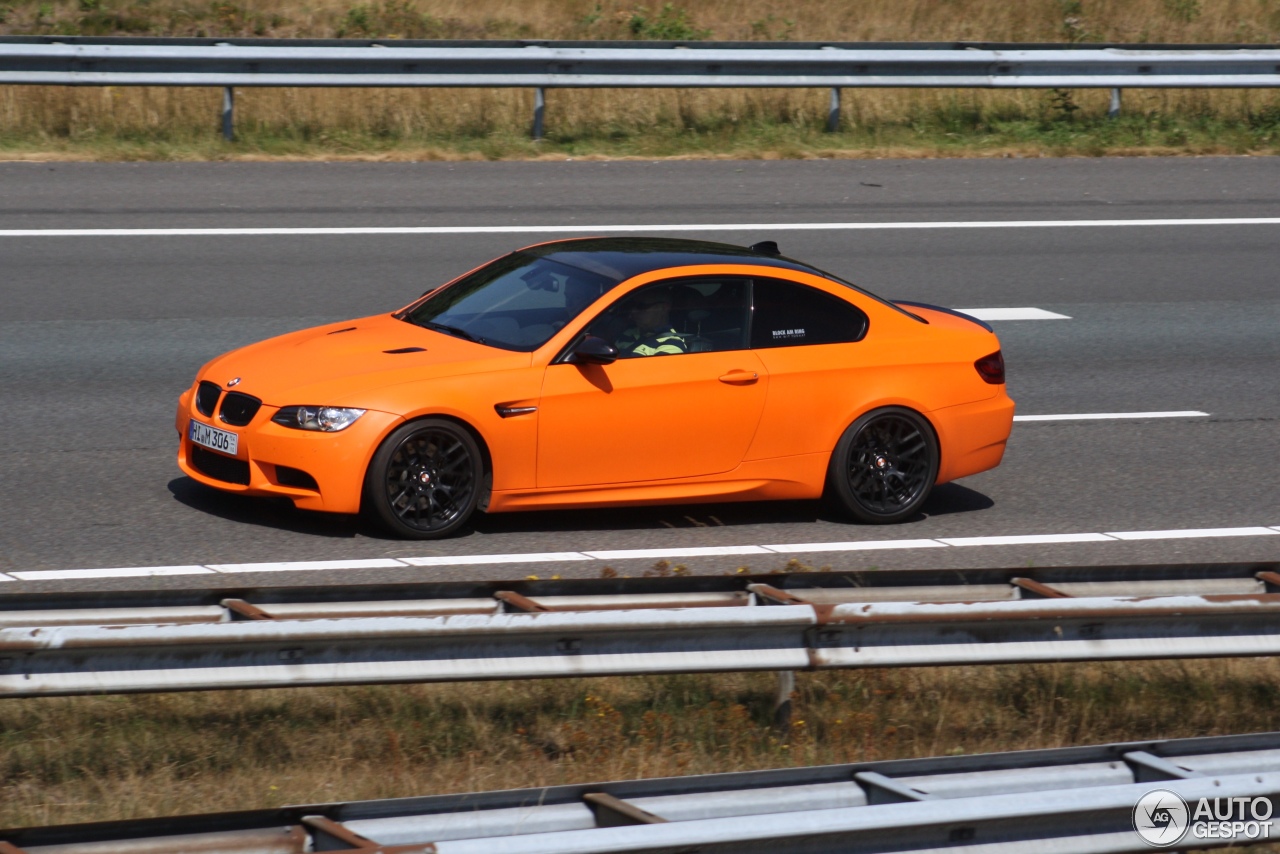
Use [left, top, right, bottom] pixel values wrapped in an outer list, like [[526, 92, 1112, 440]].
[[827, 406, 938, 525]]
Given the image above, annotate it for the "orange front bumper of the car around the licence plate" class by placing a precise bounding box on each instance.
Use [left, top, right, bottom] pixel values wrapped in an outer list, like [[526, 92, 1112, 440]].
[[175, 391, 402, 513]]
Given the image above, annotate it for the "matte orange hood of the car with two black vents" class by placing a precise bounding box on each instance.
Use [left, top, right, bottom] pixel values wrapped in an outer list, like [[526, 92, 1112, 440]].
[[200, 315, 531, 408]]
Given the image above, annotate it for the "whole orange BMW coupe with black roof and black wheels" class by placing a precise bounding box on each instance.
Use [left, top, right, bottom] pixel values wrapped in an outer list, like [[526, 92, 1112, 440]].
[[177, 237, 1014, 539]]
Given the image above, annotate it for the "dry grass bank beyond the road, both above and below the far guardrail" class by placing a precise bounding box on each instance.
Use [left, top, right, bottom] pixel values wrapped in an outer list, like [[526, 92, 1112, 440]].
[[0, 0, 1280, 159]]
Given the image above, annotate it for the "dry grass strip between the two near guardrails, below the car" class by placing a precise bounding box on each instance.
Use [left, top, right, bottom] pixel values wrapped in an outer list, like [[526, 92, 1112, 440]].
[[0, 659, 1280, 827]]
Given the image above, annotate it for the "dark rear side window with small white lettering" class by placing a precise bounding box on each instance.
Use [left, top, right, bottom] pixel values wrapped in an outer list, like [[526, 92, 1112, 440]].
[[751, 279, 868, 350]]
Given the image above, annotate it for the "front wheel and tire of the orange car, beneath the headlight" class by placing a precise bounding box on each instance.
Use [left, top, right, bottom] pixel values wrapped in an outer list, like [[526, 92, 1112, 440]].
[[365, 419, 484, 539]]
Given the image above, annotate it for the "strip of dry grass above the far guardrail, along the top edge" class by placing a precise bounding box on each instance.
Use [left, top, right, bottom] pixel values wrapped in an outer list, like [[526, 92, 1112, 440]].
[[0, 0, 1280, 42]]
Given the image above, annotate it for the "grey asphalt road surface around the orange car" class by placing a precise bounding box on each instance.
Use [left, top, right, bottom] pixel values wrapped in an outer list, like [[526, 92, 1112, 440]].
[[0, 157, 1280, 590]]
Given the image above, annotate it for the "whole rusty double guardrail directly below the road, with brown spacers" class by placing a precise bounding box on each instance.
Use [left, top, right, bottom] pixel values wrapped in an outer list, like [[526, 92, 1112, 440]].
[[0, 563, 1280, 702]]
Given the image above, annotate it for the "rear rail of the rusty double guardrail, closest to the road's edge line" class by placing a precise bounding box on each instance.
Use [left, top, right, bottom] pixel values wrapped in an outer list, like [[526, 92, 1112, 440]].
[[0, 561, 1280, 627]]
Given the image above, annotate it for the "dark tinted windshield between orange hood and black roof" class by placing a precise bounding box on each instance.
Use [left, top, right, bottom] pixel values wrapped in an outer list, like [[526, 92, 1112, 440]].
[[399, 252, 622, 352]]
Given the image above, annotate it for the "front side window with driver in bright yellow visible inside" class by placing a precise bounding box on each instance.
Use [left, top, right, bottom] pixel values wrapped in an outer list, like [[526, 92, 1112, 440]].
[[586, 277, 750, 359]]
